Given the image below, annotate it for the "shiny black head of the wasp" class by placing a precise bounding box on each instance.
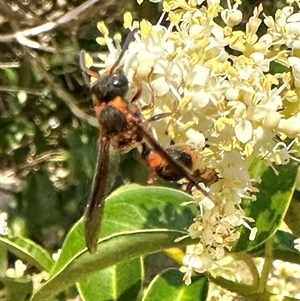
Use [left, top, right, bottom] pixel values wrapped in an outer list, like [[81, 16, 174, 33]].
[[92, 70, 128, 102]]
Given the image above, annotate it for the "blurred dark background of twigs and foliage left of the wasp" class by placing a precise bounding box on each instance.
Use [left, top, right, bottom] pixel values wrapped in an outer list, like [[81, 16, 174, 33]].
[[0, 0, 164, 251]]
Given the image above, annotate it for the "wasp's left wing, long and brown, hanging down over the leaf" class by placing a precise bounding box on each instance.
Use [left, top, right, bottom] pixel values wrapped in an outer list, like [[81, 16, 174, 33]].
[[84, 135, 119, 253]]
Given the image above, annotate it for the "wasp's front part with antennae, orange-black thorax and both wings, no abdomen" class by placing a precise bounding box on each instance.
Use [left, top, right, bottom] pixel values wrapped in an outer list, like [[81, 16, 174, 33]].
[[80, 30, 214, 253]]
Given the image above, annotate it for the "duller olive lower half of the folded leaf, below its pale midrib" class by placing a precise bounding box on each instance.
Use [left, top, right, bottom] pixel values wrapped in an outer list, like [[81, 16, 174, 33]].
[[31, 229, 191, 301]]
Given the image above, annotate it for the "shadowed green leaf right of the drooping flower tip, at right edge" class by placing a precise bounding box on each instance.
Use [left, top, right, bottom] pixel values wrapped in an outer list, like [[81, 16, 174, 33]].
[[234, 161, 299, 252]]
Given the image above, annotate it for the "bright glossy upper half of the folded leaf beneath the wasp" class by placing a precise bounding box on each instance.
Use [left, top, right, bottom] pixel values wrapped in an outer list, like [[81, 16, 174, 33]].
[[52, 184, 193, 274]]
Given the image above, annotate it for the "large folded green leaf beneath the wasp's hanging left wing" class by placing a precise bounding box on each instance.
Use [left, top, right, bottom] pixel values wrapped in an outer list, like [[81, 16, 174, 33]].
[[32, 185, 194, 301]]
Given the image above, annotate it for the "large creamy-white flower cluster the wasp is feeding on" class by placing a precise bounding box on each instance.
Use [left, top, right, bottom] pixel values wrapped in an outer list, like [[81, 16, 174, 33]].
[[89, 0, 300, 284]]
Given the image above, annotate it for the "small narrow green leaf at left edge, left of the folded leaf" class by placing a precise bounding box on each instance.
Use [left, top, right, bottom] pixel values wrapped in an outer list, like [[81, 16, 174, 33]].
[[0, 236, 54, 272]]
